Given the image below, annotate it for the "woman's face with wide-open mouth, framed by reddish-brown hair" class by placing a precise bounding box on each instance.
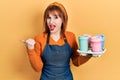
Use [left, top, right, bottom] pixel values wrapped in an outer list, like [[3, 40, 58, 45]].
[[47, 12, 62, 34]]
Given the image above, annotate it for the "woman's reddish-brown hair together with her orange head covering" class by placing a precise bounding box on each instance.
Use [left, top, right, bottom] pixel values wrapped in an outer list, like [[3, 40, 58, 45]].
[[43, 2, 68, 34]]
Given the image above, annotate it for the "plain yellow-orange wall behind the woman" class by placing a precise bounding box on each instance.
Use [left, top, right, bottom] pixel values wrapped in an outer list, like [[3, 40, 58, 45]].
[[0, 0, 120, 80]]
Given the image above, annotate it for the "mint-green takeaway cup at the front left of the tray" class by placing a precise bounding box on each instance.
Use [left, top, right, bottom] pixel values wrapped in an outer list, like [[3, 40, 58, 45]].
[[78, 36, 89, 51]]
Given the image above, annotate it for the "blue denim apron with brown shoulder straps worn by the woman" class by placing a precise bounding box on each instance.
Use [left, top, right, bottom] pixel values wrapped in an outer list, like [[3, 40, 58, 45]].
[[40, 35, 73, 80]]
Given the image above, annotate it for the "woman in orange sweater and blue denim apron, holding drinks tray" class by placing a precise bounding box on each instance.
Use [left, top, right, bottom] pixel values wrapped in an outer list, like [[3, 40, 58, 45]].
[[25, 2, 91, 80]]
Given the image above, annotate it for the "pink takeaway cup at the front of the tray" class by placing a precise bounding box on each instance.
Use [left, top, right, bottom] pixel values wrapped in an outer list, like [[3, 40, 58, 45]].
[[90, 36, 102, 52]]
